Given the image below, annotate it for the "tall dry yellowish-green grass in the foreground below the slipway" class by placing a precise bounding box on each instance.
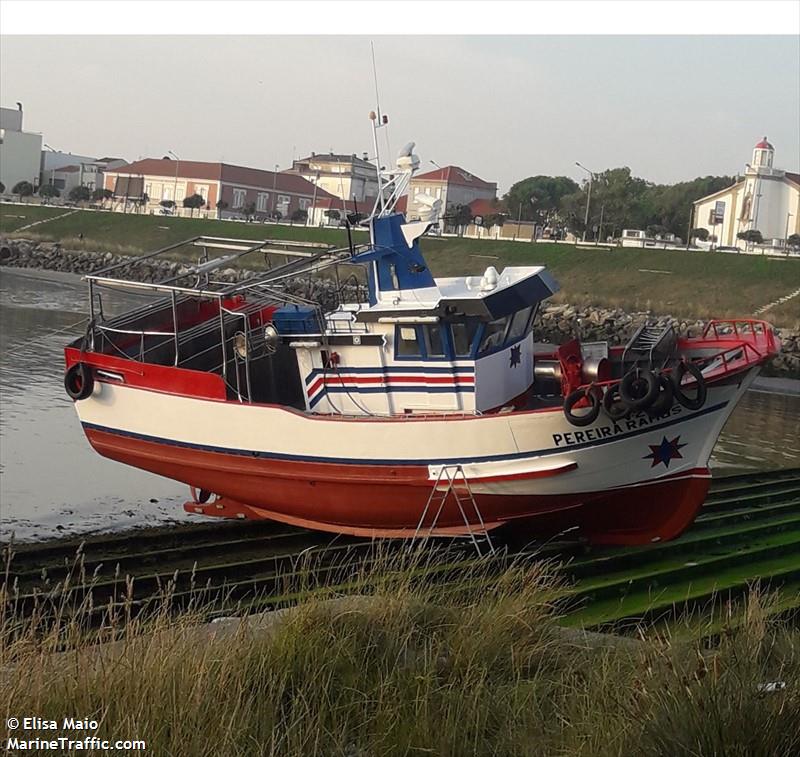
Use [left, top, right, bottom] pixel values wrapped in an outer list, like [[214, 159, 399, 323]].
[[0, 554, 800, 757]]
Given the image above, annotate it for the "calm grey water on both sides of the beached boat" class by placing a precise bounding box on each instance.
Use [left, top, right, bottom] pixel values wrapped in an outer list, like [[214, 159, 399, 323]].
[[0, 268, 800, 539]]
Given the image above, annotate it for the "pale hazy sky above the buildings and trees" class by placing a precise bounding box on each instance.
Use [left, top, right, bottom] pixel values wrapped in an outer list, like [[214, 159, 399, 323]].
[[0, 35, 800, 193]]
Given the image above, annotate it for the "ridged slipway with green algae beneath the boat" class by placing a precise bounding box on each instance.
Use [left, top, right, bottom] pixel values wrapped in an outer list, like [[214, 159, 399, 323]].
[[5, 468, 800, 627]]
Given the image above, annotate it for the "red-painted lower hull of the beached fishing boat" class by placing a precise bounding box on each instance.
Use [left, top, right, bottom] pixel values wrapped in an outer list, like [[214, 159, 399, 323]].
[[85, 427, 710, 544]]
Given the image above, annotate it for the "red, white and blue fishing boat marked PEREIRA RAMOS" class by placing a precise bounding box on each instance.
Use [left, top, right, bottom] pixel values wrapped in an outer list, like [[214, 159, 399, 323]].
[[64, 133, 779, 544]]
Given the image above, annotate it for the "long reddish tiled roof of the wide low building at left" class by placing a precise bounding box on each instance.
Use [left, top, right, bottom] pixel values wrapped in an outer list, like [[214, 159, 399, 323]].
[[108, 158, 333, 198]]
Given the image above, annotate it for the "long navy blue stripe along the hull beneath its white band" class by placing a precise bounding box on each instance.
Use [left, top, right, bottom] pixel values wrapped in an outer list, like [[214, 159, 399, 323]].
[[83, 401, 728, 467]]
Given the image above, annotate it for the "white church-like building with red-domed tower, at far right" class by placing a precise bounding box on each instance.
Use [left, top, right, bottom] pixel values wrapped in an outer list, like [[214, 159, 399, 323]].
[[692, 137, 800, 248]]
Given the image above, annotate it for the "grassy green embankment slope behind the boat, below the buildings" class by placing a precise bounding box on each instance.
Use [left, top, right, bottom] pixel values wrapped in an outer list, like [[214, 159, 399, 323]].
[[6, 205, 800, 327]]
